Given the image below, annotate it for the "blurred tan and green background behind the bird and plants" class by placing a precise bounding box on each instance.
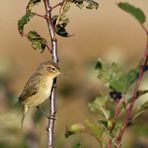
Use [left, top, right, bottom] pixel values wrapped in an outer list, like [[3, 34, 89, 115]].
[[0, 0, 148, 148]]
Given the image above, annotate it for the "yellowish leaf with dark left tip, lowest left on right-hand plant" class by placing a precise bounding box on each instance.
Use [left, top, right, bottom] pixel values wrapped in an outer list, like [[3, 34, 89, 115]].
[[65, 123, 85, 138]]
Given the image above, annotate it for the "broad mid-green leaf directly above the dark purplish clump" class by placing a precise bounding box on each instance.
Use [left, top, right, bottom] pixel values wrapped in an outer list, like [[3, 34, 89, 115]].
[[110, 66, 139, 93]]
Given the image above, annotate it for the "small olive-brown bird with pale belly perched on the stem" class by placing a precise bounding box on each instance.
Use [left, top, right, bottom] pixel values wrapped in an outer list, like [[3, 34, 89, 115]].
[[18, 61, 63, 127]]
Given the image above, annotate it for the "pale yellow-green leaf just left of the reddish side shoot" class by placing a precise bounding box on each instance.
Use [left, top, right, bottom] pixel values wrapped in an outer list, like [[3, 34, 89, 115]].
[[88, 95, 110, 120]]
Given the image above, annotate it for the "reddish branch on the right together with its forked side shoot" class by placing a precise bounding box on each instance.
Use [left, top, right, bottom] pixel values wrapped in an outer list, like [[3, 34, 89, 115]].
[[107, 24, 148, 148]]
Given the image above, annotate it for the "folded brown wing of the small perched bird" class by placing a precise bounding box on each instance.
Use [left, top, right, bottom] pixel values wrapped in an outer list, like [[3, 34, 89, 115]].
[[18, 75, 39, 102]]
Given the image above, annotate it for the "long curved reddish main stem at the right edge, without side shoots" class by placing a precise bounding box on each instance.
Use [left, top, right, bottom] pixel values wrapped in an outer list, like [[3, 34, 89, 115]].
[[115, 24, 148, 148]]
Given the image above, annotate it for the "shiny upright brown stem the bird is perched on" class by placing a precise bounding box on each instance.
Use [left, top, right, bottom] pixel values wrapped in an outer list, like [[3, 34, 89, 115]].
[[43, 0, 59, 148]]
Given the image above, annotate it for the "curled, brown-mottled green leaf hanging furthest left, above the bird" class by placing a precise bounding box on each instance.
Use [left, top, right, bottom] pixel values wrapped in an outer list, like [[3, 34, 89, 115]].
[[18, 12, 34, 36]]
